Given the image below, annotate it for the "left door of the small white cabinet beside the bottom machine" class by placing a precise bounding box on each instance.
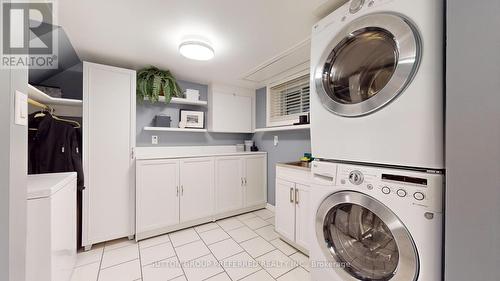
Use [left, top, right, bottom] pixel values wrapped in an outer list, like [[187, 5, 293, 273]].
[[275, 179, 295, 241]]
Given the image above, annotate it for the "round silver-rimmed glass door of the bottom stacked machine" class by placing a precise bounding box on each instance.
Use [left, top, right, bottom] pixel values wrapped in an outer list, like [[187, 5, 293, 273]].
[[312, 192, 419, 281]]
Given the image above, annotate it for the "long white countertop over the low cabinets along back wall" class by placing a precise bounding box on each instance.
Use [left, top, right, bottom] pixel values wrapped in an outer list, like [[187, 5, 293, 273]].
[[135, 145, 267, 160]]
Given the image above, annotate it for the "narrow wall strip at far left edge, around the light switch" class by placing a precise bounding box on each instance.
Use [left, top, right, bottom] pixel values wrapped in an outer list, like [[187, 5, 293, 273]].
[[0, 66, 28, 281]]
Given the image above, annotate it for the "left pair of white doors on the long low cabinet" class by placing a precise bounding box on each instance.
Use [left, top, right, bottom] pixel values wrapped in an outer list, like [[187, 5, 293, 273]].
[[136, 158, 214, 235]]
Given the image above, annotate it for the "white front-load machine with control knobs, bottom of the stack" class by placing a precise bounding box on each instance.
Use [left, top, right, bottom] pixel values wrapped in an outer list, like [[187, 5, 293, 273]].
[[310, 161, 444, 281]]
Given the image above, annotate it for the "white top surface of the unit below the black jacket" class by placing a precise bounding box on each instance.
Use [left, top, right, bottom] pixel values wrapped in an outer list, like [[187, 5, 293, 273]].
[[28, 172, 76, 200]]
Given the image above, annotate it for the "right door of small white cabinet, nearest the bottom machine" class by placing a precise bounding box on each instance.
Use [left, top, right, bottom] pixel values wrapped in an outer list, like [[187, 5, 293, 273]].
[[295, 183, 311, 250]]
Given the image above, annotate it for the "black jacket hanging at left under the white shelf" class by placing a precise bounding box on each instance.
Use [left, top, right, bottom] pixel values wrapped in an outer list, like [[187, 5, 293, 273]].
[[28, 113, 84, 190]]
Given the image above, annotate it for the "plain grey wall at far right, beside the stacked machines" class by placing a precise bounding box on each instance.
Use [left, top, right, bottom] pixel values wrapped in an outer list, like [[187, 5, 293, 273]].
[[445, 0, 500, 281]]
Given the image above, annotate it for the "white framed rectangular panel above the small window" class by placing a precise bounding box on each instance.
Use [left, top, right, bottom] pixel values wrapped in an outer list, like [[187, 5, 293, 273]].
[[242, 38, 311, 85]]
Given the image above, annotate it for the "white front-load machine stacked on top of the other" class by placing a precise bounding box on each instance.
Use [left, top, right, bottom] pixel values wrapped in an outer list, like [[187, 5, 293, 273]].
[[311, 0, 444, 169]]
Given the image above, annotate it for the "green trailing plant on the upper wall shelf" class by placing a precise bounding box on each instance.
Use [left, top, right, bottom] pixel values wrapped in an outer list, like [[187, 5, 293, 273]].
[[137, 66, 182, 103]]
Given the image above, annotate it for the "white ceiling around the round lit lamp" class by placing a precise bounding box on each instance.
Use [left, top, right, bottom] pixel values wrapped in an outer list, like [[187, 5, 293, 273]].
[[58, 0, 337, 87]]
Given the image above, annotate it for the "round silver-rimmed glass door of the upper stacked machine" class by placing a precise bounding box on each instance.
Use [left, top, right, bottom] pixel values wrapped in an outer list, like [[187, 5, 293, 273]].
[[314, 14, 420, 117]]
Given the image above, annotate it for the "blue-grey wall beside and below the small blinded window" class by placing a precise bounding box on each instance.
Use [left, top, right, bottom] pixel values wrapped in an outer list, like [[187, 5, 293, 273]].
[[253, 88, 311, 205]]
